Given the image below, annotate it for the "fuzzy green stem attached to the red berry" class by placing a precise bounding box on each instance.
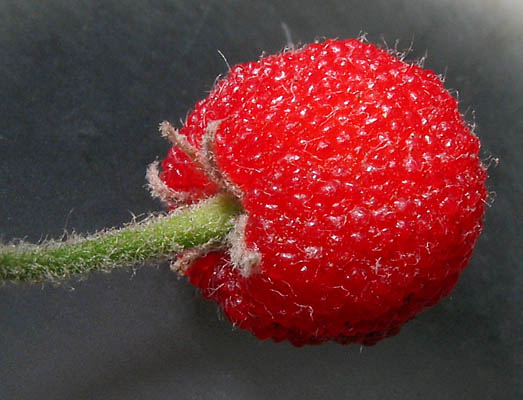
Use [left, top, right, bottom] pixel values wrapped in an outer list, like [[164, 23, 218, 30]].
[[0, 195, 241, 282]]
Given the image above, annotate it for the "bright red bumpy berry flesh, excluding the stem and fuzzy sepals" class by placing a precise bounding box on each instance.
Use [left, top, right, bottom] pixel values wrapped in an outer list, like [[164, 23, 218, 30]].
[[162, 40, 487, 345]]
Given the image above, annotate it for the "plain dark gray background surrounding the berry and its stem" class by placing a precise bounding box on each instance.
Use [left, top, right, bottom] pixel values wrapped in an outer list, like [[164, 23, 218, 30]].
[[0, 0, 523, 400]]
